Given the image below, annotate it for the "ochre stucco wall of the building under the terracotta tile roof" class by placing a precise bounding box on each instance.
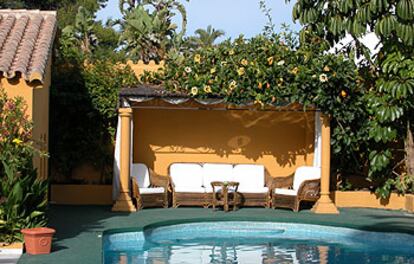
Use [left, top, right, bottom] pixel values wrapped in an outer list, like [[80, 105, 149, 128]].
[[0, 53, 52, 179]]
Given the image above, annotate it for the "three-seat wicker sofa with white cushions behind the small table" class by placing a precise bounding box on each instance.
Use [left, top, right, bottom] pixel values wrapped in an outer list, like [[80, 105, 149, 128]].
[[169, 163, 273, 207]]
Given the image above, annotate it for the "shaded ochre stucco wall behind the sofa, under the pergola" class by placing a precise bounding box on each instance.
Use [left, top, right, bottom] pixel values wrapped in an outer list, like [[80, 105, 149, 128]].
[[133, 109, 314, 176]]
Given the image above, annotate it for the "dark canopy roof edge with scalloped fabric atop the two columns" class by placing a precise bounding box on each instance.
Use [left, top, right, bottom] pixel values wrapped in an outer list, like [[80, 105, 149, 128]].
[[119, 85, 318, 112]]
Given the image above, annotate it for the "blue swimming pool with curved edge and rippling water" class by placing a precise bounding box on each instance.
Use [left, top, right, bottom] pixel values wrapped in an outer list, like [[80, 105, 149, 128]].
[[103, 221, 414, 264]]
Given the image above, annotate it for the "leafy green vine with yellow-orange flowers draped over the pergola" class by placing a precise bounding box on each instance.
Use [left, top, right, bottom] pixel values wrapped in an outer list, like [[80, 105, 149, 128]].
[[143, 32, 367, 179]]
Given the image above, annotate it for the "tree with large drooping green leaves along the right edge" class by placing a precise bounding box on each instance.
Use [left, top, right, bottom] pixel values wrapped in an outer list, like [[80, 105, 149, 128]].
[[293, 0, 414, 197]]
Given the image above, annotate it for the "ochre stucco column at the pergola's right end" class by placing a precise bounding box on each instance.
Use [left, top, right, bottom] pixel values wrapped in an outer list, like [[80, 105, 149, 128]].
[[312, 115, 339, 214]]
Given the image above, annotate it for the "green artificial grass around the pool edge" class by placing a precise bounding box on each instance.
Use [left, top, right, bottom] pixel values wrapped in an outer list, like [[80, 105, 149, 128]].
[[18, 206, 414, 264]]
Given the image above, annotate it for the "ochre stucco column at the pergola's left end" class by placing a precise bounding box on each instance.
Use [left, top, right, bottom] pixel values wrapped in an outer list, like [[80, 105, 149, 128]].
[[112, 108, 136, 212]]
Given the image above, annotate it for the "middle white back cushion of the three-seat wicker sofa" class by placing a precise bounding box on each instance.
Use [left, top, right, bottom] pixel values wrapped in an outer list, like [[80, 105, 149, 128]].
[[203, 163, 233, 188]]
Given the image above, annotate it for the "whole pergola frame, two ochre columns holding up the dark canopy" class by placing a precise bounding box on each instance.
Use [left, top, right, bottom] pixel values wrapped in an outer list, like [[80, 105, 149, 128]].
[[112, 85, 338, 214]]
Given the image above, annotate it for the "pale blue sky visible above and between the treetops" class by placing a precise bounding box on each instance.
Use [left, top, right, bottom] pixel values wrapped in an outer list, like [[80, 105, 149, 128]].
[[97, 0, 300, 38]]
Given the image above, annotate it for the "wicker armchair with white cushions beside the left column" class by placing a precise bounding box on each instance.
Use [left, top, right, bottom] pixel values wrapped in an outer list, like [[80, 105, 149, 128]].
[[131, 163, 170, 210]]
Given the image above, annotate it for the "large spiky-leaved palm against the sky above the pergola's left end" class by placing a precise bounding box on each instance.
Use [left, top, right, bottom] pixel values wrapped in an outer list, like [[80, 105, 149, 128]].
[[121, 0, 187, 62]]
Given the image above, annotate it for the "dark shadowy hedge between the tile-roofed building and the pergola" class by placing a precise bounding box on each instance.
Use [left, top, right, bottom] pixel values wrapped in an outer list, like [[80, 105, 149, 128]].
[[50, 60, 136, 184]]
